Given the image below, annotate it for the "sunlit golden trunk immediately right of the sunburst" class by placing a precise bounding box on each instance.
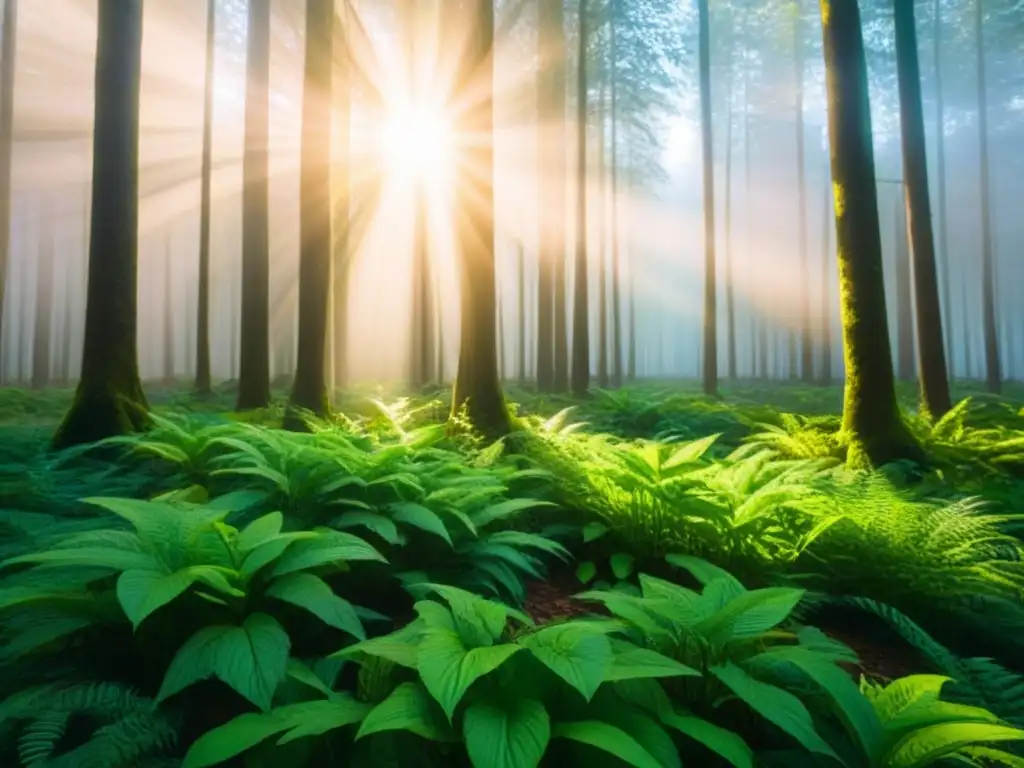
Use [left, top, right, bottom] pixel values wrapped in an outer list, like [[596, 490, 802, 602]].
[[445, 0, 511, 437]]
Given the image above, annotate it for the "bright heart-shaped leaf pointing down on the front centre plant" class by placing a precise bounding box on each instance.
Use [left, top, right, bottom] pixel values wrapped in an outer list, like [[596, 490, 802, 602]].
[[417, 628, 520, 721]]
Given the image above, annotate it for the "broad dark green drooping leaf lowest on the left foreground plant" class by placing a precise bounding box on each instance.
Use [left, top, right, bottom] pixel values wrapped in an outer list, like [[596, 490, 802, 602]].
[[157, 613, 291, 711]]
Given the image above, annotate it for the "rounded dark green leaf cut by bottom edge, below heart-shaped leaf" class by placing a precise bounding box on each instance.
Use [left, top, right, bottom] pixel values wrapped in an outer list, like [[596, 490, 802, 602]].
[[462, 698, 551, 768]]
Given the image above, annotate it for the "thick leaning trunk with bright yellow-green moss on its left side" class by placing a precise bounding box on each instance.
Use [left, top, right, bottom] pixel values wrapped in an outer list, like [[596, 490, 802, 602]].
[[821, 0, 921, 467]]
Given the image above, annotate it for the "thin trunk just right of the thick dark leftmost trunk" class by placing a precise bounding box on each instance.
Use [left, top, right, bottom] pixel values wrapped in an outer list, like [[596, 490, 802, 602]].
[[196, 0, 217, 395]]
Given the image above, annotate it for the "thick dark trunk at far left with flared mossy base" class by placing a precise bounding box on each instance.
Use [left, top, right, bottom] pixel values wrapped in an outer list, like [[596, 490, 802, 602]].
[[53, 0, 148, 449]]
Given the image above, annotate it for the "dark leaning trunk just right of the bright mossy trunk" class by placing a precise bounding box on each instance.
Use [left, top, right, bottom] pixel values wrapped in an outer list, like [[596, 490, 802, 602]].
[[893, 0, 951, 419]]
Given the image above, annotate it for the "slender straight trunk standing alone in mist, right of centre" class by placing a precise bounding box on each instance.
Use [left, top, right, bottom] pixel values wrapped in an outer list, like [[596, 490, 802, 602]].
[[697, 0, 718, 396]]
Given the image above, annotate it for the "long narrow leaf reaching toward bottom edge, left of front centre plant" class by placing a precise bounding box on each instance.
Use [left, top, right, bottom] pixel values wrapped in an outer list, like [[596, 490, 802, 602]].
[[182, 696, 370, 768]]
